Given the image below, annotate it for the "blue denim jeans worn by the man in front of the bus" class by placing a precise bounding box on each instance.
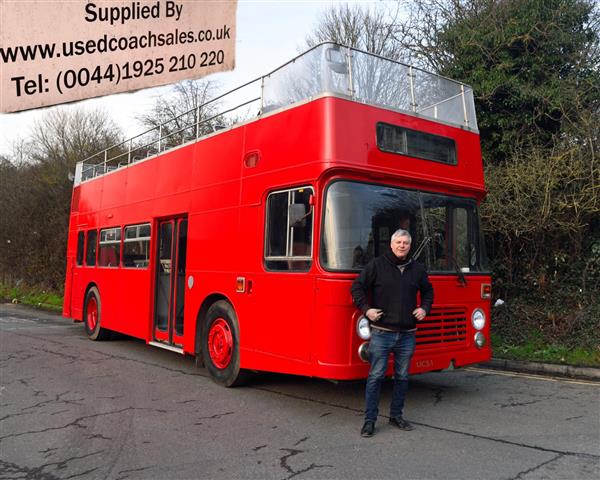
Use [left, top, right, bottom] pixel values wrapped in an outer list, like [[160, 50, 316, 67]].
[[365, 328, 416, 422]]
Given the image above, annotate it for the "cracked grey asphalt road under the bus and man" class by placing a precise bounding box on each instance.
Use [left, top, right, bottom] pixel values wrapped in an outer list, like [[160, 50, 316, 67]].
[[0, 305, 600, 480]]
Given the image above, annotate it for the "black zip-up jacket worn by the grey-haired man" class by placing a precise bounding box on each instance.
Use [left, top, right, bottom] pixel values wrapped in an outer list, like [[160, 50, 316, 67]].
[[352, 251, 433, 330]]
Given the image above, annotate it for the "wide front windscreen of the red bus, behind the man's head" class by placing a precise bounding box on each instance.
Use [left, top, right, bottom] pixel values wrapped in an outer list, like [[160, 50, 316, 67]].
[[321, 181, 488, 274]]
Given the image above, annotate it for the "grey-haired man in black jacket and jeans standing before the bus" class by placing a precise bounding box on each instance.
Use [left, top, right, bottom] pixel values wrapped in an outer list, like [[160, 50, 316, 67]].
[[352, 229, 433, 437]]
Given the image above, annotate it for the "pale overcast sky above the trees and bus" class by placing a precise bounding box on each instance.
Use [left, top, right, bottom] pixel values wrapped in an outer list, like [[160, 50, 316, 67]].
[[0, 0, 376, 154]]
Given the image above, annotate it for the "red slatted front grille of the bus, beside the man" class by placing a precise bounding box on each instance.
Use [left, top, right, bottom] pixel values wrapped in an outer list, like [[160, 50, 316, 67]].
[[417, 307, 467, 348]]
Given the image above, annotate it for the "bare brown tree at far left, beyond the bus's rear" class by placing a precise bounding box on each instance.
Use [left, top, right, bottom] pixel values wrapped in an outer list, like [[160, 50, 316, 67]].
[[0, 108, 122, 290]]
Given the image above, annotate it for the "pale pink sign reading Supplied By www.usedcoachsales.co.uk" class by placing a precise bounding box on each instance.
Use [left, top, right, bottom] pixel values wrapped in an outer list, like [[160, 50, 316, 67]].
[[0, 0, 237, 112]]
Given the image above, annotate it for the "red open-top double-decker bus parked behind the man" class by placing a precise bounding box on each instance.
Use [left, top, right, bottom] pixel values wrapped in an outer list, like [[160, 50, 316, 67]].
[[63, 43, 491, 386]]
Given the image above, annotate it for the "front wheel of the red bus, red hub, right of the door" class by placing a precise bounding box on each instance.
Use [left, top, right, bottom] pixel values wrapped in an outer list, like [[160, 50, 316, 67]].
[[202, 300, 247, 387]]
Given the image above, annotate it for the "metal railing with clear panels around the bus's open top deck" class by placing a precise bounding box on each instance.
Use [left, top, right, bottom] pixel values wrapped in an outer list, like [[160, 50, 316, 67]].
[[75, 43, 477, 185]]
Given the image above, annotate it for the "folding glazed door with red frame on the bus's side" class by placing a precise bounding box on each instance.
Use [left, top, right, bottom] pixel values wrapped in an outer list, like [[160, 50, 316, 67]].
[[154, 217, 188, 347]]
